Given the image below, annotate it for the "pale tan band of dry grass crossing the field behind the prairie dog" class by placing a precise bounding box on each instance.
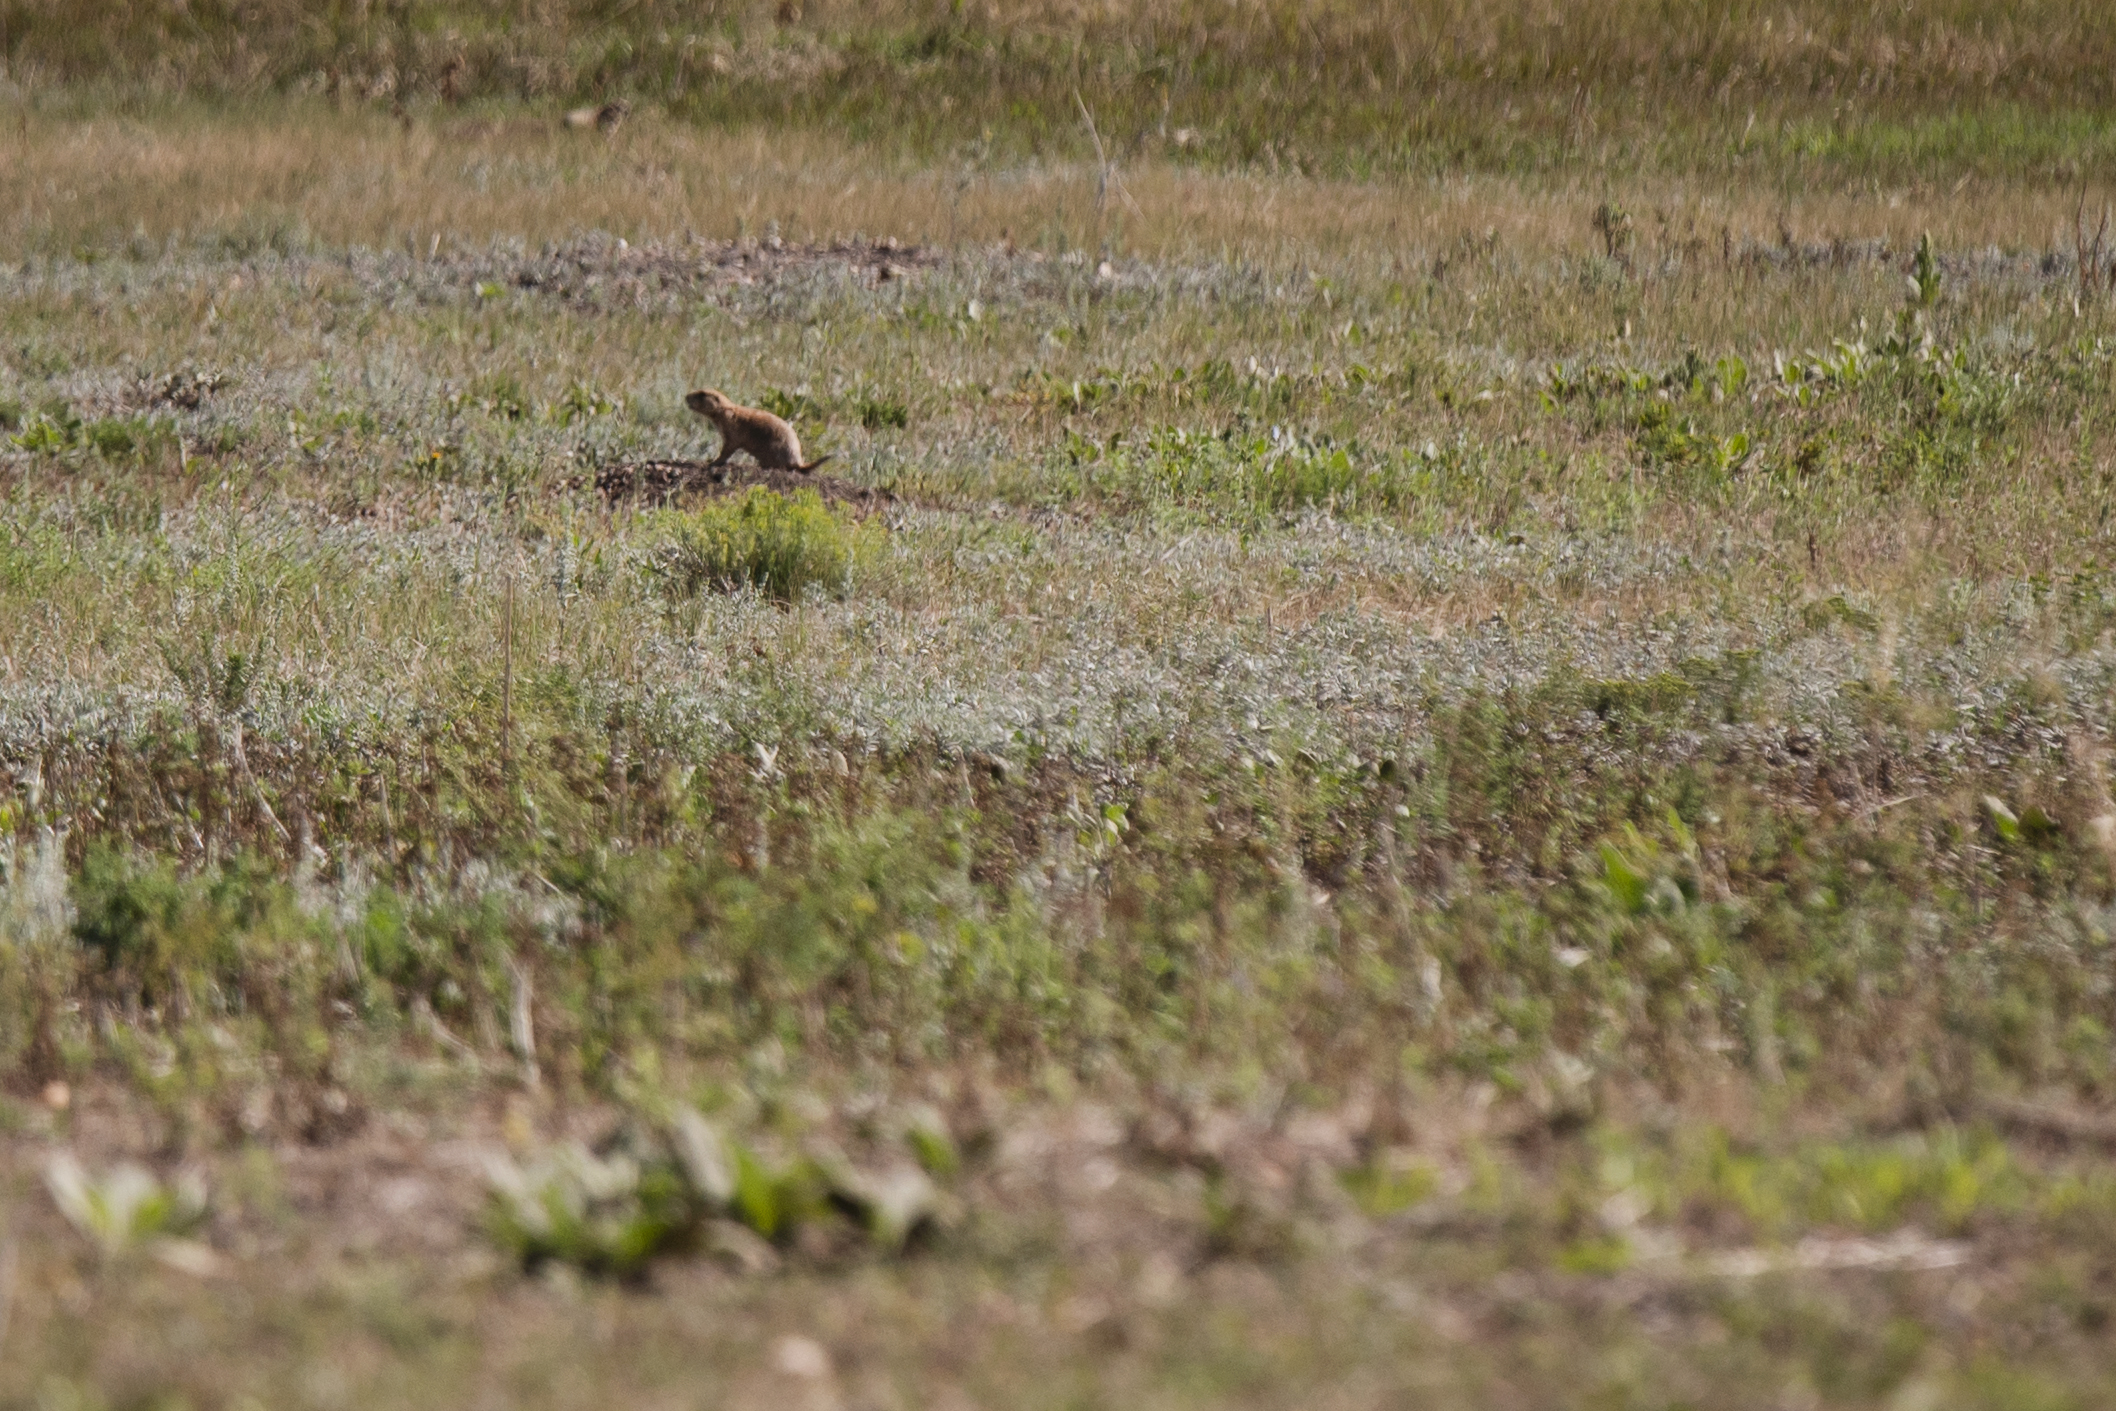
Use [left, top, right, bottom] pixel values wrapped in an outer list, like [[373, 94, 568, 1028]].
[[12, 104, 2116, 266]]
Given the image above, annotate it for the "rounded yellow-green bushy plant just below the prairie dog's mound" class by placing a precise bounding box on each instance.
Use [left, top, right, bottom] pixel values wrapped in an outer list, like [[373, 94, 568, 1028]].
[[654, 487, 859, 603]]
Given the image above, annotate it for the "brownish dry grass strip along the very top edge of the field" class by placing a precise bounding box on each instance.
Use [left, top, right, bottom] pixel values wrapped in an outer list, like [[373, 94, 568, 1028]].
[[6, 0, 2110, 121]]
